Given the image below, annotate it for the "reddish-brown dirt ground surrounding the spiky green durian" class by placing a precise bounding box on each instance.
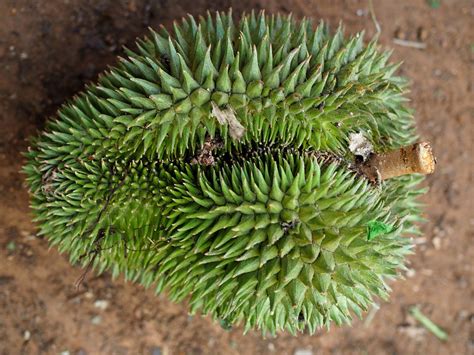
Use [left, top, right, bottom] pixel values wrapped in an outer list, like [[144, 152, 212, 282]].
[[0, 0, 474, 355]]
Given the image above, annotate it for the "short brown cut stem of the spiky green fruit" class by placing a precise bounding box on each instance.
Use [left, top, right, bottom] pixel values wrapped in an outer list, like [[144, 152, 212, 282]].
[[361, 142, 436, 181]]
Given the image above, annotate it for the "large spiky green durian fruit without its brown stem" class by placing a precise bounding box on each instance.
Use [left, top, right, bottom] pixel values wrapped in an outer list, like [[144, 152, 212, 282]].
[[24, 12, 436, 334]]
